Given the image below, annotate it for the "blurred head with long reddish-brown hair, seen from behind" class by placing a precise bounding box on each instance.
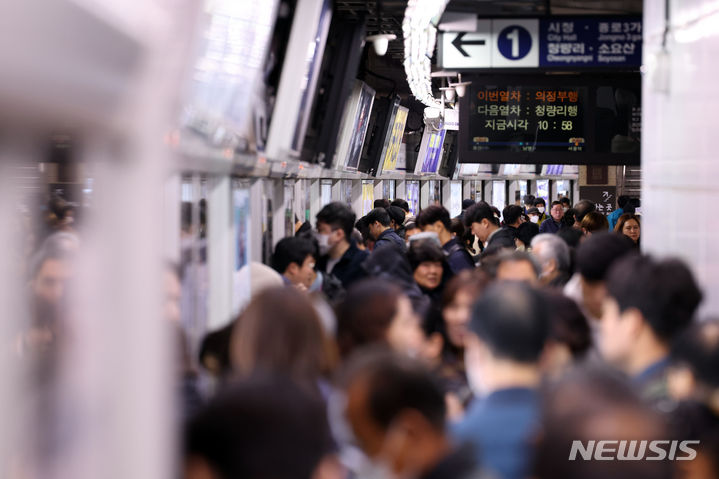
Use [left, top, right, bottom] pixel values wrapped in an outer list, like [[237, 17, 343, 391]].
[[230, 287, 334, 384]]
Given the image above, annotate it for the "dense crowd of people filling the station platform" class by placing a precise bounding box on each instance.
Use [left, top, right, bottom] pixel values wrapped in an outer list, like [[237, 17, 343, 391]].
[[184, 197, 719, 479]]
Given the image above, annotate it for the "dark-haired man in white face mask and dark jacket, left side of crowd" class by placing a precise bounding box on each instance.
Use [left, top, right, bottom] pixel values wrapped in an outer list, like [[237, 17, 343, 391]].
[[317, 201, 369, 289]]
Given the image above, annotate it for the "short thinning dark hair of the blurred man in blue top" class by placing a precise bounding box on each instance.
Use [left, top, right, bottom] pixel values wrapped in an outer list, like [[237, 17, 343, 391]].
[[470, 281, 549, 363]]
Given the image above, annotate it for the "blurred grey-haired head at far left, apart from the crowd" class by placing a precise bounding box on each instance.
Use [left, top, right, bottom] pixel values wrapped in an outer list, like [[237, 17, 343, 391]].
[[30, 240, 75, 304]]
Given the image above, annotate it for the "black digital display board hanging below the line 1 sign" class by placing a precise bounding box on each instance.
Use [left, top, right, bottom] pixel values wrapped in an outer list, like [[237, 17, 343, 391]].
[[459, 73, 641, 165]]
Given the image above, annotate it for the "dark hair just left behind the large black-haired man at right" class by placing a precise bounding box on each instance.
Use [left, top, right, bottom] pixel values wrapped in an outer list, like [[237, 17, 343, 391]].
[[577, 232, 634, 281]]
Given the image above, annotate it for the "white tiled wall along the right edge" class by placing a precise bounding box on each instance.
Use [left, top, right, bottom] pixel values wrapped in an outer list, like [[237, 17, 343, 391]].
[[642, 0, 719, 315]]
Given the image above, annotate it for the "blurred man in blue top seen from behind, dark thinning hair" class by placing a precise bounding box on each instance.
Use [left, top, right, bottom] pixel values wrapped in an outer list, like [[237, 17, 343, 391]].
[[452, 282, 550, 479]]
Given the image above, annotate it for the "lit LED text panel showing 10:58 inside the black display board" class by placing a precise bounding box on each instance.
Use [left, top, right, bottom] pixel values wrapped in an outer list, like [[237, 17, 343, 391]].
[[469, 86, 587, 152]]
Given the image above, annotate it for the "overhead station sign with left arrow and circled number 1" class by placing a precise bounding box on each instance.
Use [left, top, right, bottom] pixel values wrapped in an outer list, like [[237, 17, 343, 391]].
[[439, 17, 642, 70]]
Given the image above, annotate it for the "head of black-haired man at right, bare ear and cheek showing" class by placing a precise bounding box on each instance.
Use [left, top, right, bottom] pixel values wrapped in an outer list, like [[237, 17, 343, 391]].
[[599, 255, 702, 374]]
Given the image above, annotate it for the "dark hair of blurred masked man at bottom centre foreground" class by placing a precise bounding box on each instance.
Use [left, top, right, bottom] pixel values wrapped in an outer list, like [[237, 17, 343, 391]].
[[343, 350, 446, 431]]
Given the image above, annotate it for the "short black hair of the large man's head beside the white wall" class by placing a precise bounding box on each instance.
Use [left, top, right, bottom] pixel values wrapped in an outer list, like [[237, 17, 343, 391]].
[[607, 255, 702, 340]]
